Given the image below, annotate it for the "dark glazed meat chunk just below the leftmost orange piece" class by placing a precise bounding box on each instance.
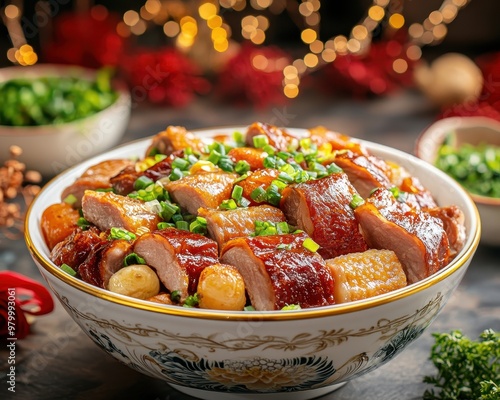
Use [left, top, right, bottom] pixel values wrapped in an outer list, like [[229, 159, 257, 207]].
[[50, 227, 107, 271]]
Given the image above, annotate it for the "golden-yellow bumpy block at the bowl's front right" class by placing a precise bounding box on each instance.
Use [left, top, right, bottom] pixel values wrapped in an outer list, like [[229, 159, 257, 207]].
[[326, 249, 406, 303]]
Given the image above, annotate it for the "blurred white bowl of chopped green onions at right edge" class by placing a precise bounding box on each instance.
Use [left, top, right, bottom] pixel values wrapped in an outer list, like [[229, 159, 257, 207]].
[[415, 117, 500, 246]]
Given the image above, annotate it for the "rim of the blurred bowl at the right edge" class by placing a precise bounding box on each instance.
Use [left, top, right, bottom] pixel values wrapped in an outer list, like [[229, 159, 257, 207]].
[[414, 116, 500, 206]]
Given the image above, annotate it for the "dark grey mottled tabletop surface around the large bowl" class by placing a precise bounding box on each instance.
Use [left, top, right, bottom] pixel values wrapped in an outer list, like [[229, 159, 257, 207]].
[[0, 92, 500, 400]]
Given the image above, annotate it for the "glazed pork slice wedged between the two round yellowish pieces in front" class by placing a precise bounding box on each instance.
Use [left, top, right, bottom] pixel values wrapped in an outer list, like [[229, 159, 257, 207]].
[[134, 228, 219, 301]]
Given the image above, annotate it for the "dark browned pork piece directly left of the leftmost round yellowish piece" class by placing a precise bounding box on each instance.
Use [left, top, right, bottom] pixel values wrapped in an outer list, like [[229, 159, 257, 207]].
[[78, 239, 132, 288]]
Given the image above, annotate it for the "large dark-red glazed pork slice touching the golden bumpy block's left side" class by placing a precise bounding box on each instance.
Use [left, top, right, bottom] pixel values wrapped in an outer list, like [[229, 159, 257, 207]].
[[221, 232, 335, 311]]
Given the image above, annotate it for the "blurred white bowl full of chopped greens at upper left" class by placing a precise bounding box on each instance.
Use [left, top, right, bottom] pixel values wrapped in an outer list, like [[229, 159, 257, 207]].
[[0, 64, 131, 177]]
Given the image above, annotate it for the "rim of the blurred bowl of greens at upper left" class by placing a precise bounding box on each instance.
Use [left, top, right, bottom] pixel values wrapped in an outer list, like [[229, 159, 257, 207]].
[[0, 63, 131, 133]]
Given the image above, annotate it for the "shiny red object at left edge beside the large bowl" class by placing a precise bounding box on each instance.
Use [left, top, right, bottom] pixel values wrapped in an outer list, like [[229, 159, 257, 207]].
[[0, 271, 54, 339]]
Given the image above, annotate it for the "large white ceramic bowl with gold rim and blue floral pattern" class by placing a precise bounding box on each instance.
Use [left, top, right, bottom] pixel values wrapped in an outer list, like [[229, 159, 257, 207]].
[[25, 127, 480, 400]]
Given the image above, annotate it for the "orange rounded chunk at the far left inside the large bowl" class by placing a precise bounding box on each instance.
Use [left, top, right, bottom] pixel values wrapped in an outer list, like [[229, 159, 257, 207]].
[[40, 203, 80, 250]]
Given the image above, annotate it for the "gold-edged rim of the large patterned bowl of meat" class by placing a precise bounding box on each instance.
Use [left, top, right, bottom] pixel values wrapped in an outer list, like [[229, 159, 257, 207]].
[[24, 126, 481, 321]]
